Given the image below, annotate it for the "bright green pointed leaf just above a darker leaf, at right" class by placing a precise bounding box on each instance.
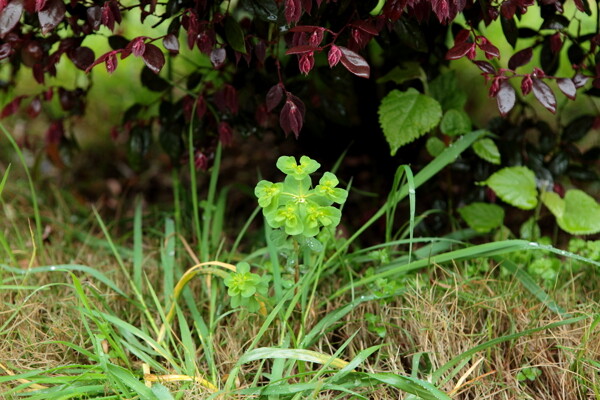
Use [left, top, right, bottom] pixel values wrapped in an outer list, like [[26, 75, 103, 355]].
[[484, 167, 537, 210]]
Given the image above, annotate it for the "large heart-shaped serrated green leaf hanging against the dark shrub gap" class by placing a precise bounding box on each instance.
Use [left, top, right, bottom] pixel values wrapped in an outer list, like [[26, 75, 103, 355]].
[[379, 88, 442, 155]]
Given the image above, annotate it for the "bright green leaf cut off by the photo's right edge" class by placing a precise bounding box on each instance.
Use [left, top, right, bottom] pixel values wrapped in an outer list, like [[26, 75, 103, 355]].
[[542, 189, 600, 235]]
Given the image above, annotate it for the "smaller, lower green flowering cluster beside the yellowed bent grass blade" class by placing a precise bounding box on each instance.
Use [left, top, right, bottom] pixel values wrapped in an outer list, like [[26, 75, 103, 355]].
[[224, 262, 271, 312]]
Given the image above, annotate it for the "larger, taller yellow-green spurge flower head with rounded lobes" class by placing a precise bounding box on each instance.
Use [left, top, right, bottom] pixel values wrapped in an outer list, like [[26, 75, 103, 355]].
[[254, 156, 348, 238]]
